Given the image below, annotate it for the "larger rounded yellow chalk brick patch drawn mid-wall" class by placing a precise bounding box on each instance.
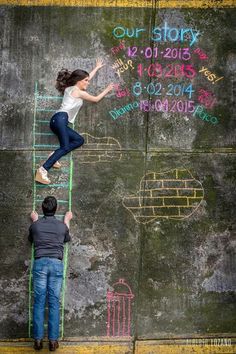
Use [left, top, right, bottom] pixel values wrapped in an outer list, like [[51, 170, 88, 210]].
[[122, 169, 204, 224]]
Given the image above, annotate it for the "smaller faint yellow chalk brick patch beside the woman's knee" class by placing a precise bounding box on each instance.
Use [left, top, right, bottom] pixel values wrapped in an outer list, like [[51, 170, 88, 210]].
[[79, 133, 122, 163]]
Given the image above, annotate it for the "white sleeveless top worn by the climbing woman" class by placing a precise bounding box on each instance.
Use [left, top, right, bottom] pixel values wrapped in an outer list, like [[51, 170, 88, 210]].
[[56, 86, 83, 123]]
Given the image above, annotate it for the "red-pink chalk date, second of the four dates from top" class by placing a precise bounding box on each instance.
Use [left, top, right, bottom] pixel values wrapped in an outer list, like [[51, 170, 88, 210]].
[[137, 63, 197, 79]]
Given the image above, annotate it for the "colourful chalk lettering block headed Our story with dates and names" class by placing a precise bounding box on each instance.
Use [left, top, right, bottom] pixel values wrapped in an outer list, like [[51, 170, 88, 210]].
[[108, 21, 224, 125]]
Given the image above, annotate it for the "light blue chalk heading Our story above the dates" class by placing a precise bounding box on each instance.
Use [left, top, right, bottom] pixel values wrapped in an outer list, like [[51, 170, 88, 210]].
[[112, 22, 200, 46]]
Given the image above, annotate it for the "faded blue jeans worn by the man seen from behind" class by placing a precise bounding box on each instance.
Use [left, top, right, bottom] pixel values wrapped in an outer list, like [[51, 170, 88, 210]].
[[33, 257, 63, 340]]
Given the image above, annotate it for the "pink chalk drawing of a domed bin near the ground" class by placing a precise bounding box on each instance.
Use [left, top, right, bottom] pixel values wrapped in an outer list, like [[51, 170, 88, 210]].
[[107, 279, 134, 337]]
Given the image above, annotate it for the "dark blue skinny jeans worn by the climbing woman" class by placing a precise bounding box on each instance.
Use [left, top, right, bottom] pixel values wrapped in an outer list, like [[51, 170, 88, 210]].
[[43, 112, 84, 171]]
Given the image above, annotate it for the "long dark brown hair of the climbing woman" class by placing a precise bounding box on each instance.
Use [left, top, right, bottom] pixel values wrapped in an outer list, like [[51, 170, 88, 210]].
[[56, 69, 89, 94]]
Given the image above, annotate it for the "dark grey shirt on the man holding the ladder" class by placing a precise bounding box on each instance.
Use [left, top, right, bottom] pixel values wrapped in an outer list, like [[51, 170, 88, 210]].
[[28, 216, 71, 259]]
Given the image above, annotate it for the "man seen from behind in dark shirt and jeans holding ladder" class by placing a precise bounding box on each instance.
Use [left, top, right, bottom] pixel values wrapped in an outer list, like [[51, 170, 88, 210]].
[[28, 196, 72, 351]]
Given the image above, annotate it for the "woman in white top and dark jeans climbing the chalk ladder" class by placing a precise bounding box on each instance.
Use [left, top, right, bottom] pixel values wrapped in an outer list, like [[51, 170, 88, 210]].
[[35, 59, 114, 184]]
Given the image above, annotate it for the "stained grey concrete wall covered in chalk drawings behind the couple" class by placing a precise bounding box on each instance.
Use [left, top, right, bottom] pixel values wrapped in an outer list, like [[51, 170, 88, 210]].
[[0, 2, 236, 339]]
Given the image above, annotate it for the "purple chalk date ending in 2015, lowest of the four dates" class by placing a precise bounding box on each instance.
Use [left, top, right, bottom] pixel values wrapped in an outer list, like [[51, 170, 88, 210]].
[[139, 98, 195, 113]]
